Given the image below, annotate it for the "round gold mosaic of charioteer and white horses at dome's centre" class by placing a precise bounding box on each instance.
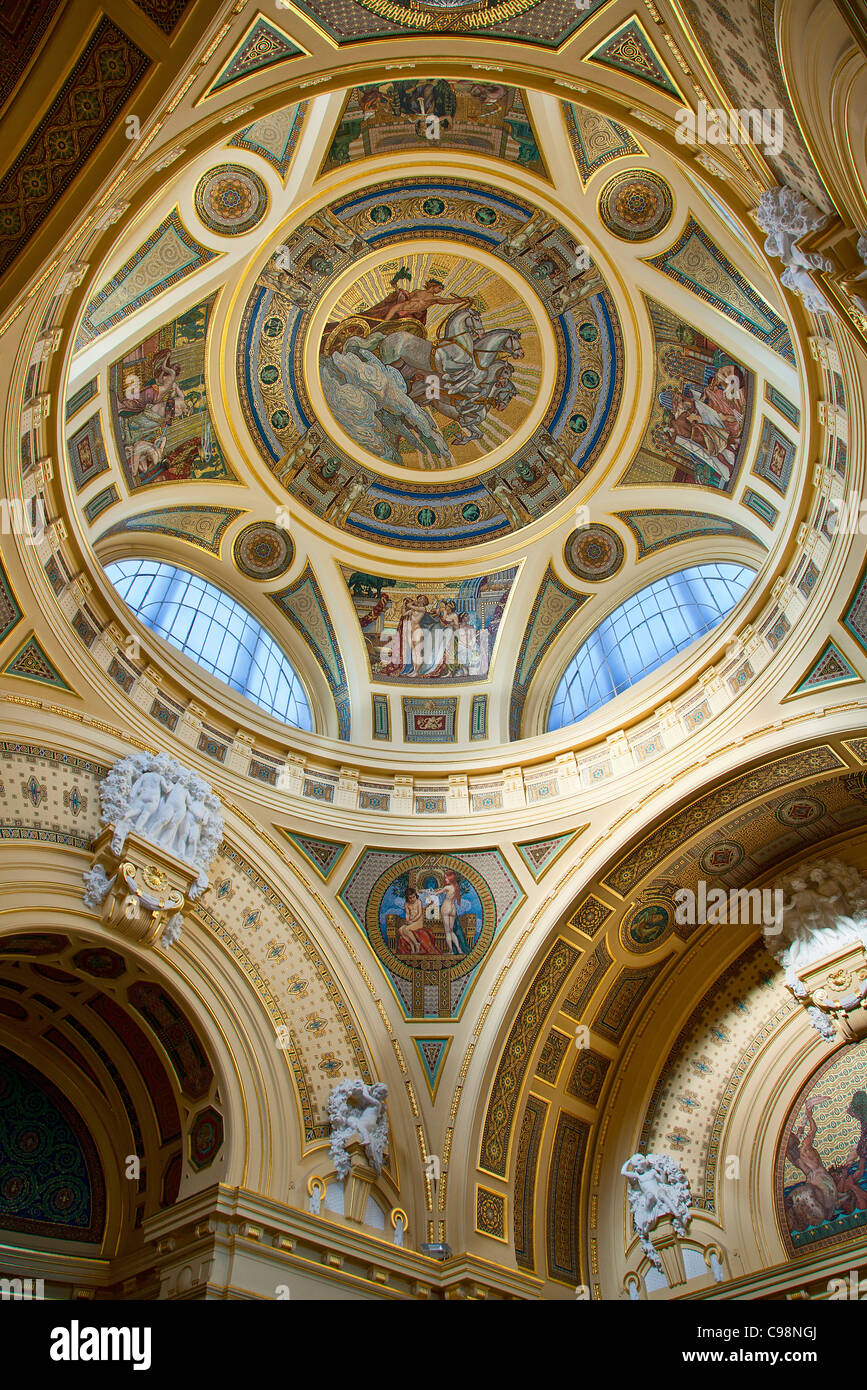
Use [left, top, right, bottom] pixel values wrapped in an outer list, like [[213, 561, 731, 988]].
[[316, 247, 553, 470]]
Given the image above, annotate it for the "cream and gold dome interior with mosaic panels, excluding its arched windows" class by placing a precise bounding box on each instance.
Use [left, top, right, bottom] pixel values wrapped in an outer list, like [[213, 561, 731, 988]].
[[67, 73, 802, 756]]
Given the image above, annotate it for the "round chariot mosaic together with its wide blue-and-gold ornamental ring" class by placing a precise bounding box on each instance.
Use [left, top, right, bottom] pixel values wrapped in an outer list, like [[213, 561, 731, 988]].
[[238, 179, 622, 549]]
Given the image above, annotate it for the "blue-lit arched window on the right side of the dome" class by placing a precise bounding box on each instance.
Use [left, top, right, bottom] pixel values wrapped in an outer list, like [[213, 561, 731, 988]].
[[547, 564, 754, 731]]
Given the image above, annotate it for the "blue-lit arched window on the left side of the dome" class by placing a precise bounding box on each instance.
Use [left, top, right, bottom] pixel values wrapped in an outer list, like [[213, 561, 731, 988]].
[[106, 560, 313, 730]]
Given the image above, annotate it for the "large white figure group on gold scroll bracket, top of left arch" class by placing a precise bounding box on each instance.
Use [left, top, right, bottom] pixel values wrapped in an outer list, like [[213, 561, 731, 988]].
[[100, 753, 222, 898]]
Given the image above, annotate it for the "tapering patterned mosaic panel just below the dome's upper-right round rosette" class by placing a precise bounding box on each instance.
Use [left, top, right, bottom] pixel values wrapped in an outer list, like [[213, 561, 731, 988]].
[[645, 217, 795, 366]]
